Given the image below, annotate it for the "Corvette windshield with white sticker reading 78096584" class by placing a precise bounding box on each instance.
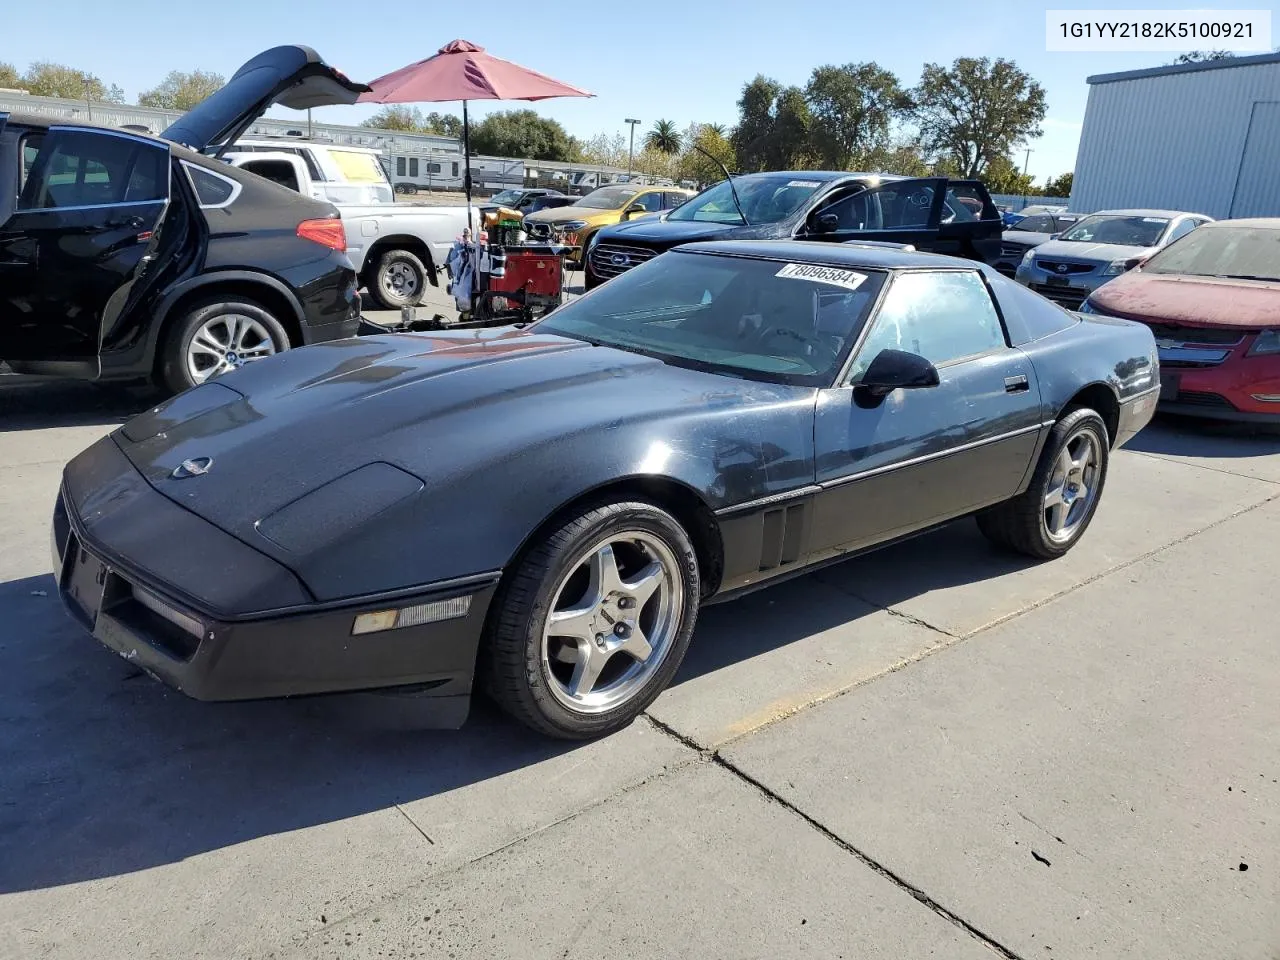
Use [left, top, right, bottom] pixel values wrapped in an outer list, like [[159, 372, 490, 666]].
[[536, 251, 884, 387]]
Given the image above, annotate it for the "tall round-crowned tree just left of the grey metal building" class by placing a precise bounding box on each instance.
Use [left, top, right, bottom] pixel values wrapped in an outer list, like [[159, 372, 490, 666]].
[[913, 56, 1047, 177]]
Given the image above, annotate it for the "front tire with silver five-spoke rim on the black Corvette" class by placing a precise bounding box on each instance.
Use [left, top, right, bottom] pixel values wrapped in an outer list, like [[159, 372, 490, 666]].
[[481, 502, 701, 740]]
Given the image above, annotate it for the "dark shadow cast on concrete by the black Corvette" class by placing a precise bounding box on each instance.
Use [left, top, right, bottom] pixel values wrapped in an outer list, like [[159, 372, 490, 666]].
[[0, 519, 1005, 893]]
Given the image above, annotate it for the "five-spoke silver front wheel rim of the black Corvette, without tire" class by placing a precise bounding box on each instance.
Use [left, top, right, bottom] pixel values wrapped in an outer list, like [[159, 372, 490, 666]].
[[541, 530, 686, 713]]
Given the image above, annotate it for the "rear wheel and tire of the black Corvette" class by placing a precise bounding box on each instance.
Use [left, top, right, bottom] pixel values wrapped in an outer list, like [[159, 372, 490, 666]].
[[978, 407, 1111, 559]]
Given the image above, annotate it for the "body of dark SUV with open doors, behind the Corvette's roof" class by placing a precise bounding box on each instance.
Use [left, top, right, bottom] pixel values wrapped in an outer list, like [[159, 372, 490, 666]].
[[586, 170, 1002, 285]]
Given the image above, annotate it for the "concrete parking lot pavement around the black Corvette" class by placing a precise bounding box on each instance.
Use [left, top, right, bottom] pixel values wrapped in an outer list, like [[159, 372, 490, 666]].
[[0, 317, 1280, 960]]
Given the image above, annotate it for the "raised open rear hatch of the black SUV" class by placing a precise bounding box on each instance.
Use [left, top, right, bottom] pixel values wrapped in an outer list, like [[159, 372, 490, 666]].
[[160, 45, 369, 156]]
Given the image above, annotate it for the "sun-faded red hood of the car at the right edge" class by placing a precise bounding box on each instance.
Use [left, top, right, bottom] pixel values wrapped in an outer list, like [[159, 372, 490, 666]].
[[1089, 271, 1280, 329]]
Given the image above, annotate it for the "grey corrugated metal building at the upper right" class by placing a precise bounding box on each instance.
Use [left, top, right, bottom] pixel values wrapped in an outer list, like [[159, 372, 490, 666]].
[[1071, 54, 1280, 219]]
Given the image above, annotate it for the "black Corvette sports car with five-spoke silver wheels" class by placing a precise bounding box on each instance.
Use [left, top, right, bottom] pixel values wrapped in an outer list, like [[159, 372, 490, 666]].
[[52, 241, 1160, 737]]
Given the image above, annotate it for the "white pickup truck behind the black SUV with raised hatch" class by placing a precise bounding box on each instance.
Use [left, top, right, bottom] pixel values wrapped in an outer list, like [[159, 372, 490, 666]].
[[223, 150, 480, 310]]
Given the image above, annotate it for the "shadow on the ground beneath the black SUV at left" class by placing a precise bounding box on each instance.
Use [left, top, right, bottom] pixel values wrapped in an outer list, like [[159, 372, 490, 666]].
[[0, 374, 163, 431]]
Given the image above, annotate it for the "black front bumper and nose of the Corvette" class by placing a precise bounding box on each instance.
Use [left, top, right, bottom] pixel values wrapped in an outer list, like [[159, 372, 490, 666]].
[[52, 438, 498, 727]]
